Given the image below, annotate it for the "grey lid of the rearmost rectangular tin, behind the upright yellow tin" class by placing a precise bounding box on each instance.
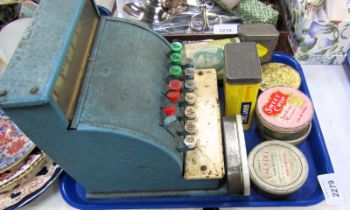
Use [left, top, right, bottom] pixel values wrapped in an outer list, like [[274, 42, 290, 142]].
[[239, 24, 279, 41]]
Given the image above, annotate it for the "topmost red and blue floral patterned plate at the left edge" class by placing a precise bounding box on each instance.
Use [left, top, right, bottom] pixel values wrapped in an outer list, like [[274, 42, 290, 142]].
[[0, 109, 35, 173]]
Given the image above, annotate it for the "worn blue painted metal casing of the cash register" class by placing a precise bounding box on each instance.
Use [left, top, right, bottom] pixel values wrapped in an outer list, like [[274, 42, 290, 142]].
[[0, 0, 222, 197]]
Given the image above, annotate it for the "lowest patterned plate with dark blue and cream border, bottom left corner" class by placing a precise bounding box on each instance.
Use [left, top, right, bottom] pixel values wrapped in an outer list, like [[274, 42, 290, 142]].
[[0, 154, 62, 209]]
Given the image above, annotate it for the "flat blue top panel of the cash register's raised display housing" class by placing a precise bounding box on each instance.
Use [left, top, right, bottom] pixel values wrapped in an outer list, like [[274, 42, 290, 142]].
[[0, 0, 89, 107]]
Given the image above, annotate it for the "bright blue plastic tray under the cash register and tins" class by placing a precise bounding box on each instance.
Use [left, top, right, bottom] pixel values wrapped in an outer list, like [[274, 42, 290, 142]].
[[60, 53, 333, 209]]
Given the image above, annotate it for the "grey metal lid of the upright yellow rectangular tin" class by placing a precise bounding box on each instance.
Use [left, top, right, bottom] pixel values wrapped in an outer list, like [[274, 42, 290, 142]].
[[224, 42, 261, 84]]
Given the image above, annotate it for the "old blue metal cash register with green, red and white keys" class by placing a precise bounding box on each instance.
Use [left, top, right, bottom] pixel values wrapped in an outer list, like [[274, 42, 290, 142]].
[[0, 0, 249, 199]]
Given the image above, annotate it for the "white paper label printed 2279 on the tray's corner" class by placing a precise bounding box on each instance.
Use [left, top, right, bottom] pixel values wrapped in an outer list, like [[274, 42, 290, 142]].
[[317, 173, 345, 205]]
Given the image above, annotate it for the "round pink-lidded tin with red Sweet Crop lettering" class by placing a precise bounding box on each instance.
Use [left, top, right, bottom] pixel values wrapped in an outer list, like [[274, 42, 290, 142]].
[[255, 87, 314, 134]]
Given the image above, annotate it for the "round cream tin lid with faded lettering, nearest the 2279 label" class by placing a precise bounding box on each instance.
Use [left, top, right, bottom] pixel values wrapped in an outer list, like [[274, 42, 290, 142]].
[[248, 141, 309, 195]]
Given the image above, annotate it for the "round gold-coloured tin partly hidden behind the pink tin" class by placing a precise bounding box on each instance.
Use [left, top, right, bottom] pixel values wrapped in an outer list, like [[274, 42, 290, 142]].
[[260, 63, 301, 91]]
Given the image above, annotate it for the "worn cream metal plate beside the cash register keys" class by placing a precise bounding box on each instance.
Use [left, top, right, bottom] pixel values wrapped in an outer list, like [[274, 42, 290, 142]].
[[184, 69, 225, 179]]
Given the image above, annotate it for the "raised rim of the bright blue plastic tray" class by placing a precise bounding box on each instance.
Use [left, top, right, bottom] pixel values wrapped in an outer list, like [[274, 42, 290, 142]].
[[59, 52, 334, 209]]
